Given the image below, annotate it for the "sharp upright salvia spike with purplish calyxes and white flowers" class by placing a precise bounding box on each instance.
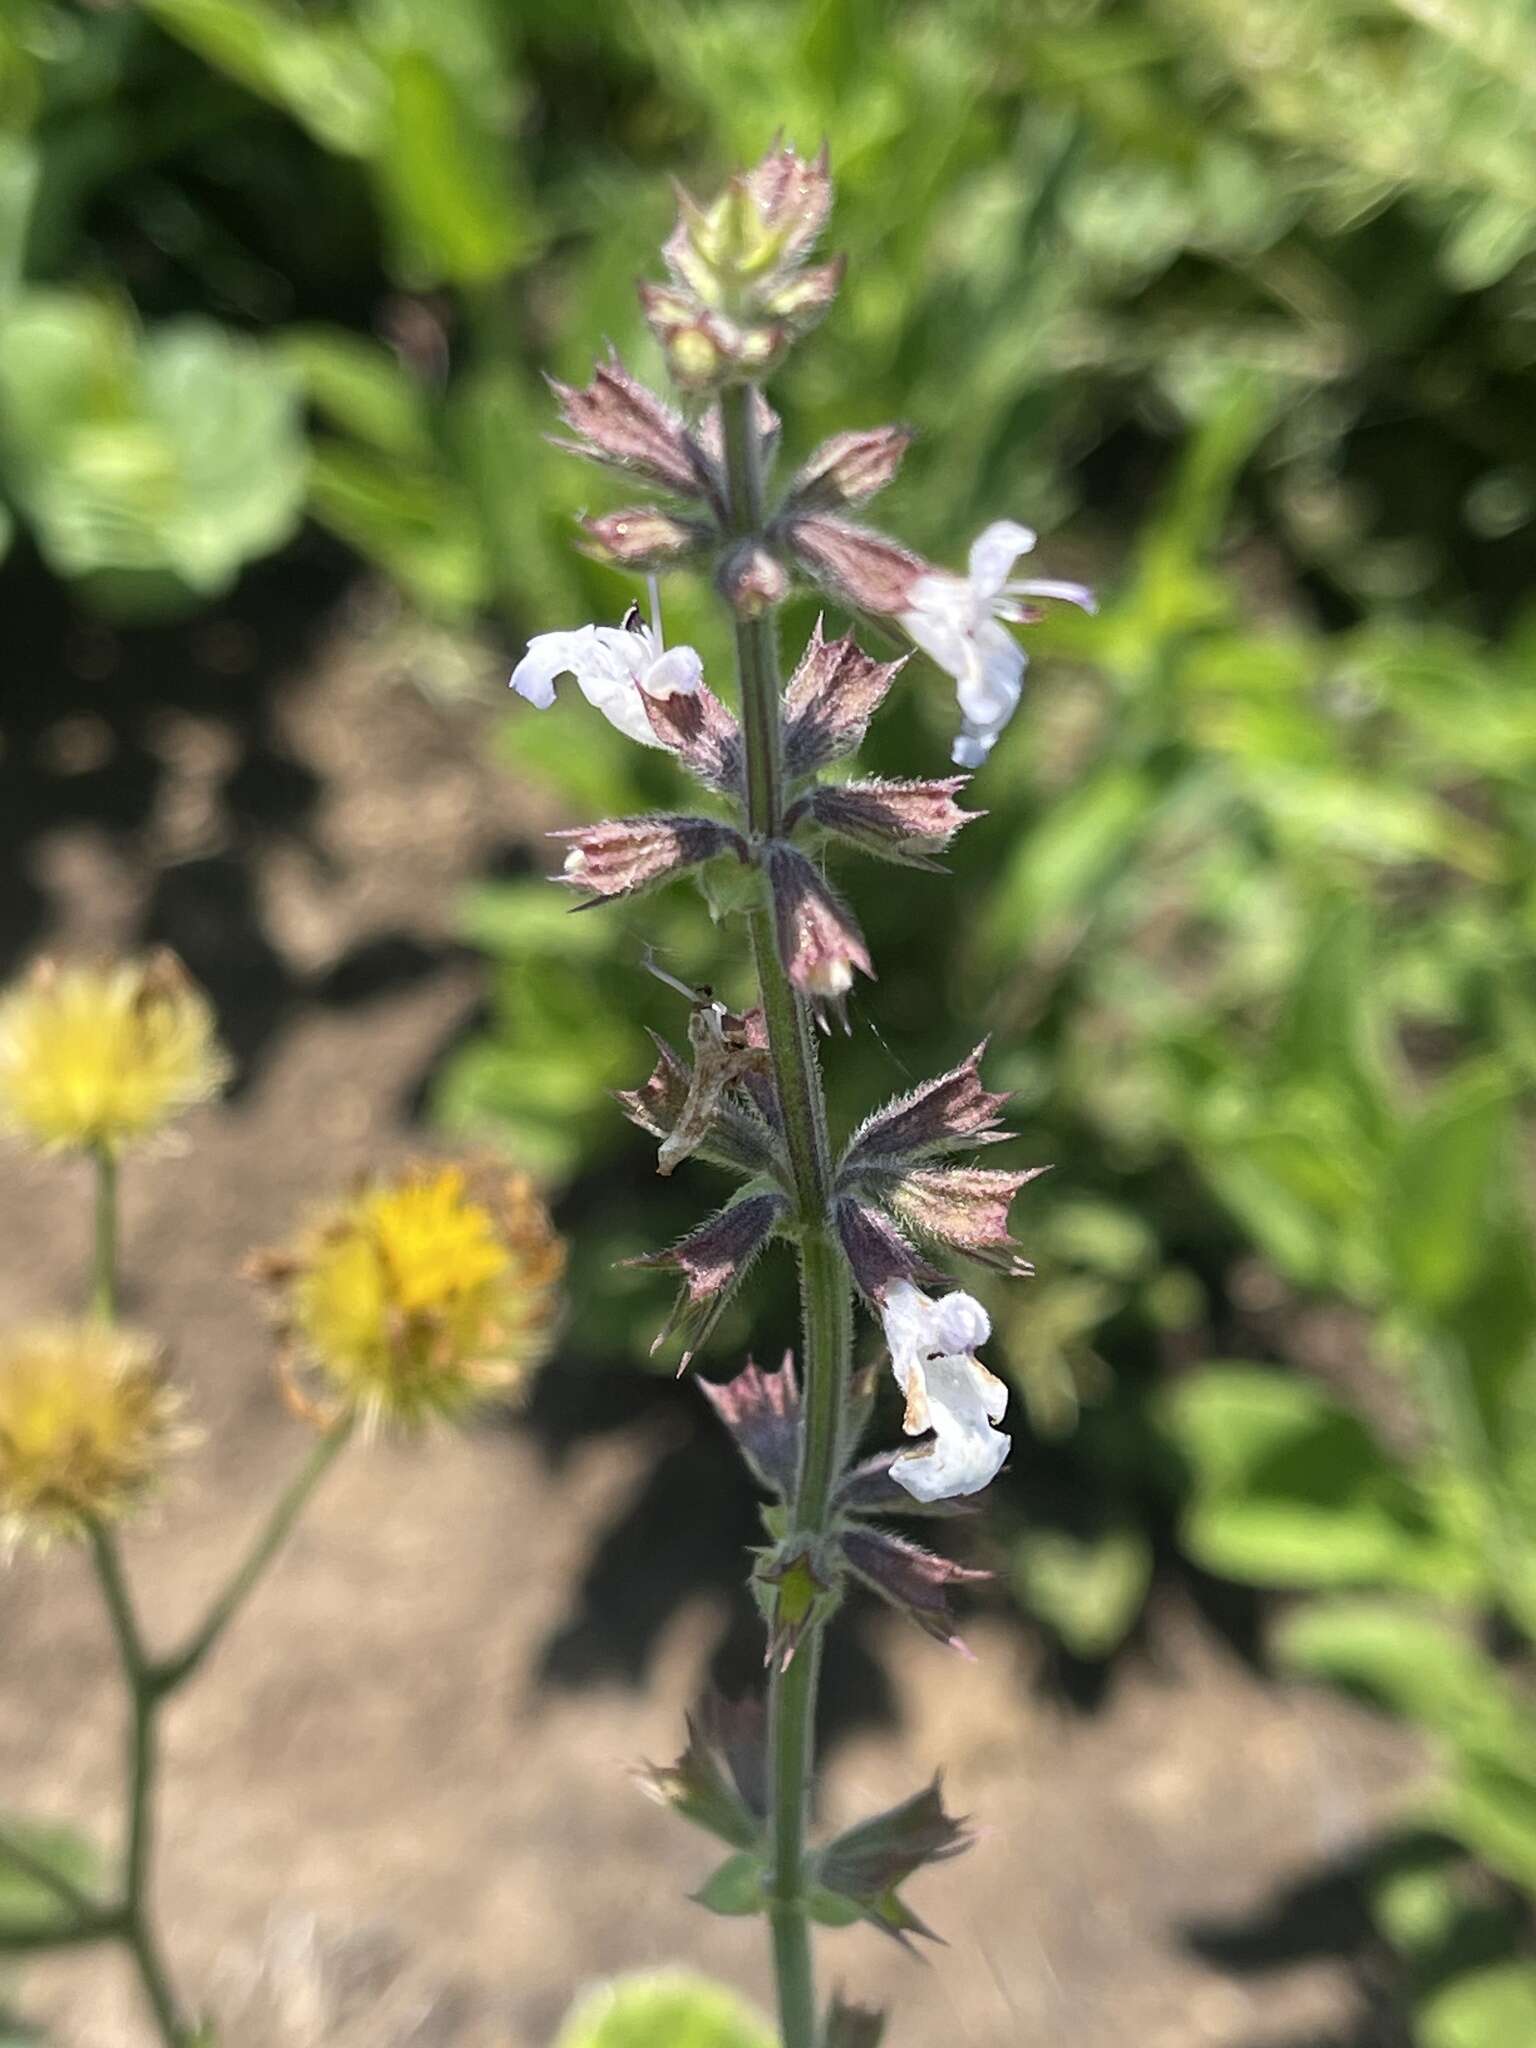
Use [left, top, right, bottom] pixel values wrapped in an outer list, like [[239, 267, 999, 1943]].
[[512, 145, 1092, 2048]]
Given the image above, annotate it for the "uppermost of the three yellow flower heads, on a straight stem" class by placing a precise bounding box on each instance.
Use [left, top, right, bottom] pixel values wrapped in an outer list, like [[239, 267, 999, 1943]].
[[0, 952, 229, 1153]]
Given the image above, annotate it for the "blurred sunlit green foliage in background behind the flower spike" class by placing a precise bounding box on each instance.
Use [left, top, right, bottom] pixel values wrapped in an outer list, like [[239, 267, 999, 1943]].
[[0, 0, 1536, 2048]]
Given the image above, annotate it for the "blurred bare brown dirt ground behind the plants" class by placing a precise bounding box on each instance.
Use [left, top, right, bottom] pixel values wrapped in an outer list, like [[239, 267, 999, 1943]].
[[0, 565, 1411, 2048]]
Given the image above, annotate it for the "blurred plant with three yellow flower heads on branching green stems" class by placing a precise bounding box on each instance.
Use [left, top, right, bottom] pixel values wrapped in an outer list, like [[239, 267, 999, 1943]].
[[0, 952, 563, 2048]]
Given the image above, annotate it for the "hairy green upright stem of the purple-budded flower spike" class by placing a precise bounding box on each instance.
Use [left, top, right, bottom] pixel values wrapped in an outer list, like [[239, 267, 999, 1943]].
[[721, 385, 852, 2048]]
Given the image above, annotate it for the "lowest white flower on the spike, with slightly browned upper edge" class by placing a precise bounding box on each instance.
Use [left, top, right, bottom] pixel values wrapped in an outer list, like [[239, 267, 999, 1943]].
[[881, 1280, 1012, 1501]]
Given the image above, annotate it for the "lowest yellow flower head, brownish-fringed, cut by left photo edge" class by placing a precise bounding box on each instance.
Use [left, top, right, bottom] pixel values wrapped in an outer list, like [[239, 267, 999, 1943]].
[[0, 1323, 186, 1544]]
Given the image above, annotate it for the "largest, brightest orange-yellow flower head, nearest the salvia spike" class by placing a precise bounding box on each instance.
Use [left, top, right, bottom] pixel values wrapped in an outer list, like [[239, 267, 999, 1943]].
[[256, 1165, 565, 1427]]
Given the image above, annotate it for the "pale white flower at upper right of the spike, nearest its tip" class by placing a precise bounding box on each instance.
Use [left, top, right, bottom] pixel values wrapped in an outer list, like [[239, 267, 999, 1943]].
[[901, 518, 1096, 768]]
